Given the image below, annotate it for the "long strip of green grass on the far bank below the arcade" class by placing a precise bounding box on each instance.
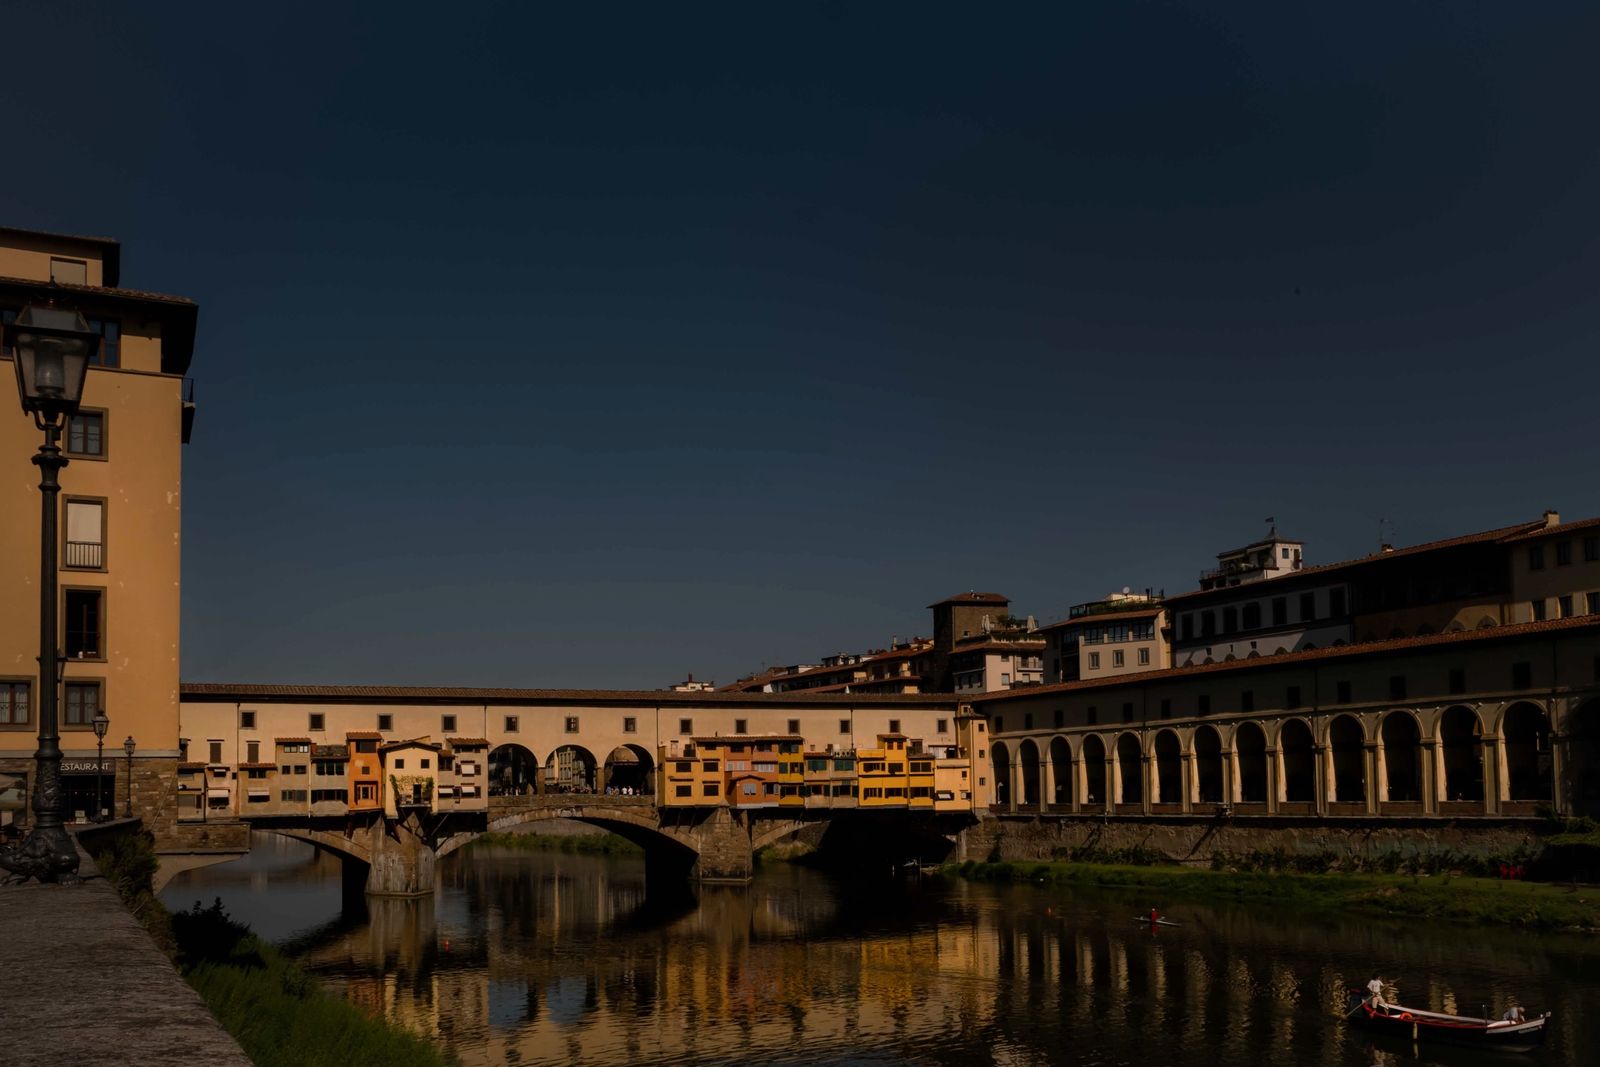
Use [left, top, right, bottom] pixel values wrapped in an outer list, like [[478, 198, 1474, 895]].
[[944, 861, 1600, 933]]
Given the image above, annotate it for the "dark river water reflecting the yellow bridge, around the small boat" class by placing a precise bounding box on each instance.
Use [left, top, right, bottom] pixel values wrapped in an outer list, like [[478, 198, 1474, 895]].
[[162, 835, 1600, 1067]]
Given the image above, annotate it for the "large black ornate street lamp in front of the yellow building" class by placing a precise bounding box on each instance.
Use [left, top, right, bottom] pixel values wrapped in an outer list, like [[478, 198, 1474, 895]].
[[0, 304, 99, 883]]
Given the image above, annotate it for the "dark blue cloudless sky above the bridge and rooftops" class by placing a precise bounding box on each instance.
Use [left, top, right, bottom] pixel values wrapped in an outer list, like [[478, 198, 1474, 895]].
[[0, 3, 1600, 688]]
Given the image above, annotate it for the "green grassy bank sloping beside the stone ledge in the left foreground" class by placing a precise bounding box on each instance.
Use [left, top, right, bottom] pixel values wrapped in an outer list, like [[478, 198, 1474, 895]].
[[94, 833, 453, 1067]]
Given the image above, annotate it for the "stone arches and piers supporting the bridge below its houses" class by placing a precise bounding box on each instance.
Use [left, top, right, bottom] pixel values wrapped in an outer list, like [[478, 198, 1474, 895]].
[[250, 793, 973, 896]]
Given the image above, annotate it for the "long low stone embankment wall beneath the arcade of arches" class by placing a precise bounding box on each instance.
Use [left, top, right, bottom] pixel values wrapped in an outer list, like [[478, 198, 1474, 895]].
[[952, 816, 1541, 865]]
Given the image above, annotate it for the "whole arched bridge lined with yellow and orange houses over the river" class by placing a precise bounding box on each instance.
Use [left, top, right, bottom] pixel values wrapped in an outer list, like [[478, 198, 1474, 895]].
[[179, 683, 972, 894]]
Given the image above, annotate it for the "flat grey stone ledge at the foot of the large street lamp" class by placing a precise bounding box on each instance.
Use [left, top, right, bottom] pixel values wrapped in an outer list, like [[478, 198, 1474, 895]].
[[0, 849, 250, 1067]]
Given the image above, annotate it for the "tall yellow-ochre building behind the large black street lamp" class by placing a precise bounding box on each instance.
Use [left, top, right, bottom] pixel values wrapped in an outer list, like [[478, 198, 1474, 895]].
[[0, 229, 198, 845]]
